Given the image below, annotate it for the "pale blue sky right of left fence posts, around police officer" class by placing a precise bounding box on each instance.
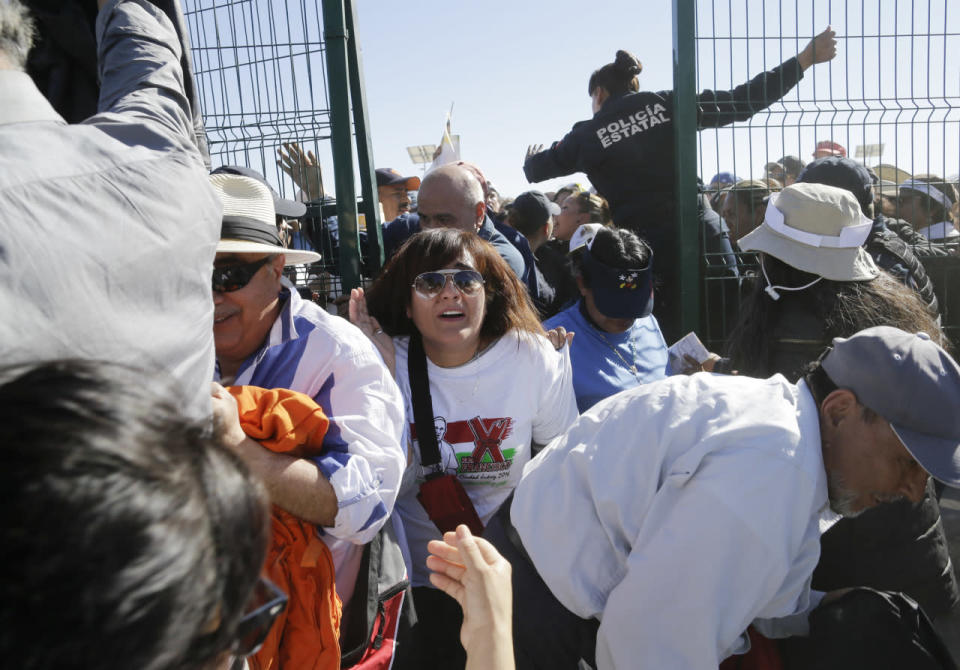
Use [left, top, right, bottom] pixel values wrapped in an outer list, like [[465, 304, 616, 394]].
[[358, 0, 960, 194]]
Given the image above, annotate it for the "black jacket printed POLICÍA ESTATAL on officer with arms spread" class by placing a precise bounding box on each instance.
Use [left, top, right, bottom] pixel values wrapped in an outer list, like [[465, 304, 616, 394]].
[[523, 58, 803, 230]]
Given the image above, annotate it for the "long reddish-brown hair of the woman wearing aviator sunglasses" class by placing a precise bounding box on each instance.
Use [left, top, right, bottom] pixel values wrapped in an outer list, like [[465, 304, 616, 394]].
[[367, 228, 544, 341]]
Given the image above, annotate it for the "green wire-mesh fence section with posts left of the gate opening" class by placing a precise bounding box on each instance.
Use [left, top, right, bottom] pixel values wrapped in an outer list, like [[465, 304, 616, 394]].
[[184, 0, 382, 302]]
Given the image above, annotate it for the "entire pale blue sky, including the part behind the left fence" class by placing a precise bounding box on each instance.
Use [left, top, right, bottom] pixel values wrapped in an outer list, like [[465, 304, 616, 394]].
[[185, 0, 960, 203]]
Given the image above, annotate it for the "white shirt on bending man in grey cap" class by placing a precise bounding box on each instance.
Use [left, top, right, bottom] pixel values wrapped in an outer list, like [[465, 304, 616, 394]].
[[511, 373, 836, 670]]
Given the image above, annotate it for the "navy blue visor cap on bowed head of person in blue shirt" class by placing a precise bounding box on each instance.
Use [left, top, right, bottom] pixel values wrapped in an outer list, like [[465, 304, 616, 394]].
[[580, 247, 653, 319]]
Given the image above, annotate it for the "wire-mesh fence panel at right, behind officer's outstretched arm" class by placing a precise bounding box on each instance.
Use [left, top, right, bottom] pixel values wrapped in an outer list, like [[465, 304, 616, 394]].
[[674, 0, 960, 350]]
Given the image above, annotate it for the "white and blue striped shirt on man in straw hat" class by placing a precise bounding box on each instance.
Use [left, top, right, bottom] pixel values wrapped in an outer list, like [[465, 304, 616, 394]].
[[216, 278, 406, 604]]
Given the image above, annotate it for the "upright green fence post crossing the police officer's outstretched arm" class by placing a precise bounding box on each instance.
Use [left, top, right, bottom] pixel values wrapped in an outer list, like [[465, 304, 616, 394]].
[[668, 0, 701, 333]]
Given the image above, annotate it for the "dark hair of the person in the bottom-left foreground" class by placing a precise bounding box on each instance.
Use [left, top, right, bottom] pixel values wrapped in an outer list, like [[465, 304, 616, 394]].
[[0, 361, 270, 670]]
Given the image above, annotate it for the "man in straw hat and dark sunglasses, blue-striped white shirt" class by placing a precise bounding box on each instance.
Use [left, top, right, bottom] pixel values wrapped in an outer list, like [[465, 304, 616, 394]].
[[209, 173, 405, 606]]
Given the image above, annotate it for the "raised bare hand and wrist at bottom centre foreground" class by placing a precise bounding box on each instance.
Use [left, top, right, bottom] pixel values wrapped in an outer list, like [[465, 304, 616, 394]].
[[427, 524, 514, 670]]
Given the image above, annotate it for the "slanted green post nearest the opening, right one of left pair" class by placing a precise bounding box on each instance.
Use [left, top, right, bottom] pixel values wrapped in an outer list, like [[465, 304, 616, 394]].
[[345, 0, 383, 272]]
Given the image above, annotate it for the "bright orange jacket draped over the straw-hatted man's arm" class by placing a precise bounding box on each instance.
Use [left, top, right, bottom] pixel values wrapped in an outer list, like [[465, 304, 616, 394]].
[[227, 386, 340, 670]]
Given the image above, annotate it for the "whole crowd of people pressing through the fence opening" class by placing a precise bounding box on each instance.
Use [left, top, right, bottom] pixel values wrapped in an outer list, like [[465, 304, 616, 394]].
[[0, 0, 960, 670]]
